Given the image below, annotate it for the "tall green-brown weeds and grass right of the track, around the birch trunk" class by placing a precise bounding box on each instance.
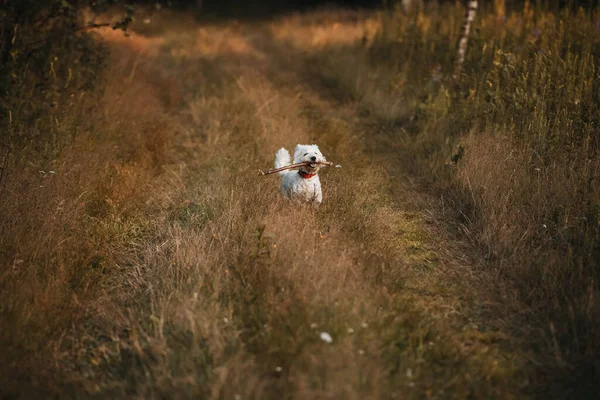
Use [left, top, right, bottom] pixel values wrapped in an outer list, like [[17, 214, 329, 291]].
[[314, 2, 600, 396]]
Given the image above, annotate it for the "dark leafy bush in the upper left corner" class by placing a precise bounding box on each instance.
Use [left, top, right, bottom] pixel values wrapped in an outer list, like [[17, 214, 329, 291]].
[[0, 0, 133, 169]]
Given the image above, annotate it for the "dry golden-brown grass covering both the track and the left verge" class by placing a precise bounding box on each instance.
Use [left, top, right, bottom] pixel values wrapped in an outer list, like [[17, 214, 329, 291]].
[[0, 6, 576, 399]]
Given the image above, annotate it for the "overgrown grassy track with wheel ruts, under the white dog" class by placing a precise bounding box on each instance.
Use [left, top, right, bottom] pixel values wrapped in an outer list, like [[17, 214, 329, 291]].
[[55, 10, 526, 399]]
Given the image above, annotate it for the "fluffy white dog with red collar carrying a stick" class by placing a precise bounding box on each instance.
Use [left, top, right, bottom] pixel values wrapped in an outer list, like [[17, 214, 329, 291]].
[[275, 144, 326, 206]]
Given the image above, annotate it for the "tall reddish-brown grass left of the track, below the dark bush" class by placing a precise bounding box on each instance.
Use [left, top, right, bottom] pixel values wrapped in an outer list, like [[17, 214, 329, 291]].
[[0, 38, 176, 393]]
